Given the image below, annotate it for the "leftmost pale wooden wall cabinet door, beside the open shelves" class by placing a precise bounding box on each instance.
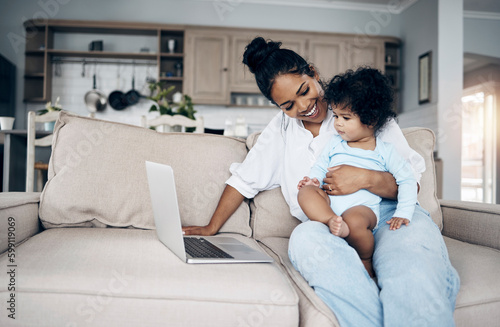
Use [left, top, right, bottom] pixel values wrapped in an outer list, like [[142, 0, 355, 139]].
[[185, 30, 229, 104]]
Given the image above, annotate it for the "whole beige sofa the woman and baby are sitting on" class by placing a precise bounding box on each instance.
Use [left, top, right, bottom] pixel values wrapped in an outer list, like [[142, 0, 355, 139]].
[[0, 112, 500, 327]]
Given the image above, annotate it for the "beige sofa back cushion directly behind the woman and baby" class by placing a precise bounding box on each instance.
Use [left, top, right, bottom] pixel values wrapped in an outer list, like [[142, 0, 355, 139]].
[[247, 127, 443, 240]]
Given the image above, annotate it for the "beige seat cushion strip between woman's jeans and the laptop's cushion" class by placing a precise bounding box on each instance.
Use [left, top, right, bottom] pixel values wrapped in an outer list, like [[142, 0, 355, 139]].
[[260, 237, 339, 327]]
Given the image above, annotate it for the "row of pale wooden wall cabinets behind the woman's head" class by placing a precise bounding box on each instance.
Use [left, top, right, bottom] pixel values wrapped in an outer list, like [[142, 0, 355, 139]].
[[185, 27, 385, 106]]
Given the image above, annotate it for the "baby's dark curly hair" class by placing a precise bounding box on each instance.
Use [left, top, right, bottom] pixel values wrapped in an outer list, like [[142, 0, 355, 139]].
[[324, 66, 396, 133]]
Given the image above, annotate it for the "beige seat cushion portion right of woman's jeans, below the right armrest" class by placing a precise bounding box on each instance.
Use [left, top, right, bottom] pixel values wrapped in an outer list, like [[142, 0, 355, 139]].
[[444, 237, 500, 326]]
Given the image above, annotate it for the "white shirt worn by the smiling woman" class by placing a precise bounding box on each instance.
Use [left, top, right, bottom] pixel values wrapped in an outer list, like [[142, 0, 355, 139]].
[[226, 110, 425, 222]]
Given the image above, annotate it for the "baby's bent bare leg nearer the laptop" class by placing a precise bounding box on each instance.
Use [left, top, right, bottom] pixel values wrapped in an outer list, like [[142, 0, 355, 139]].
[[297, 185, 337, 224]]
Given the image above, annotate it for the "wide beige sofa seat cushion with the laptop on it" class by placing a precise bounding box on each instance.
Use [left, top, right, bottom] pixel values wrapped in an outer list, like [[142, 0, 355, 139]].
[[0, 228, 299, 327]]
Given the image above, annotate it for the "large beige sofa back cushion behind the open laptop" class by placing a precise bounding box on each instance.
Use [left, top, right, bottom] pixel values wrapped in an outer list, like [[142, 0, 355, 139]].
[[40, 112, 251, 236]]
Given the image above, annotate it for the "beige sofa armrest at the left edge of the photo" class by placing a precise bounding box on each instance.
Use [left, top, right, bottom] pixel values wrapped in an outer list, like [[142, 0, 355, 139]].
[[0, 192, 41, 254]]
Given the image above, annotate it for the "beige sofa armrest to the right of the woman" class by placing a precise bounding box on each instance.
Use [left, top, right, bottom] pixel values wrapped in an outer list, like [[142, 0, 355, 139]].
[[440, 200, 500, 250]]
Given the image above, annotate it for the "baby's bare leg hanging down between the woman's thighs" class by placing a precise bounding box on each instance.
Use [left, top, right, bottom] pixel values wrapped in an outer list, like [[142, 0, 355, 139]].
[[342, 206, 377, 277]]
